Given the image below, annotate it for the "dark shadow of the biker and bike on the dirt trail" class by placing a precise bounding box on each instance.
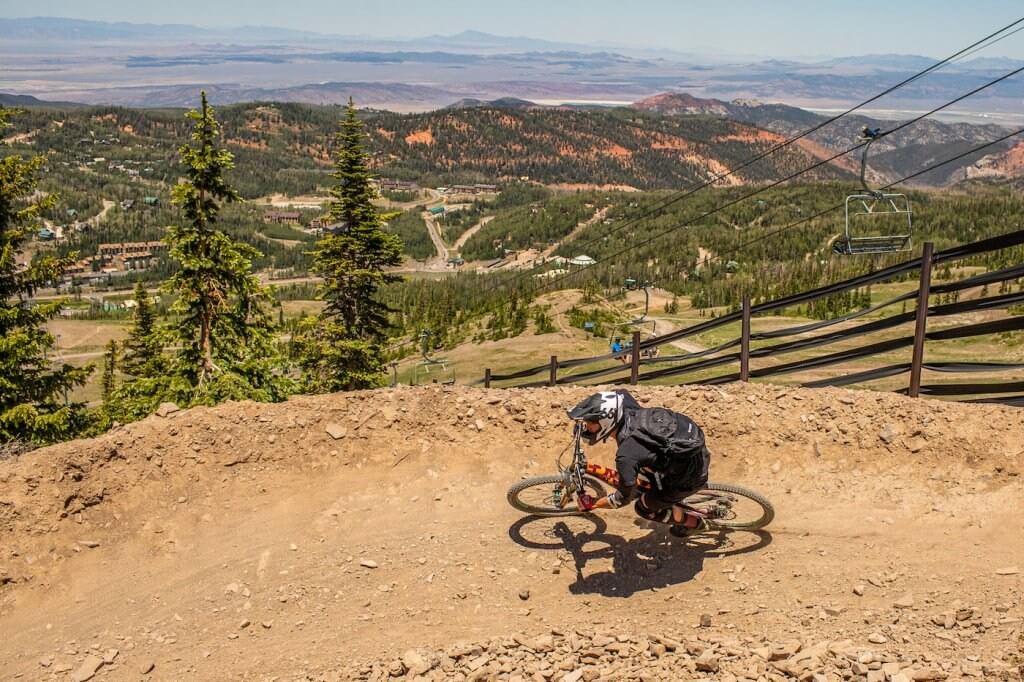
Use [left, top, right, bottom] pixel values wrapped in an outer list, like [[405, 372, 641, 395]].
[[509, 515, 772, 597]]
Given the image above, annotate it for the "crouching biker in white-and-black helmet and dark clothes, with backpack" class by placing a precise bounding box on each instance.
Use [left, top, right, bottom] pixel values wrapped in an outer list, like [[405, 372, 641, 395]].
[[568, 389, 711, 537]]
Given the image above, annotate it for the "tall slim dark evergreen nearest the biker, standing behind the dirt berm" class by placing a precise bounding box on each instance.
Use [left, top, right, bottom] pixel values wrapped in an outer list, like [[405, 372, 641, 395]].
[[295, 99, 402, 392]]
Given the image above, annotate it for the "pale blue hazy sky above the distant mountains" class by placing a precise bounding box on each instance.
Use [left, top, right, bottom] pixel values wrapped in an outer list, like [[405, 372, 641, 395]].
[[0, 0, 1024, 58]]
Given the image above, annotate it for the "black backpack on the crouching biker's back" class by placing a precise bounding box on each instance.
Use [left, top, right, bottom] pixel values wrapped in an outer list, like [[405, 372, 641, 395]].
[[622, 408, 707, 479]]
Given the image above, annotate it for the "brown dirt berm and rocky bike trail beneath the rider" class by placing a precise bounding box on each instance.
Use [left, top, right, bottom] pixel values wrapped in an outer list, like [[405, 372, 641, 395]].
[[0, 385, 1024, 682]]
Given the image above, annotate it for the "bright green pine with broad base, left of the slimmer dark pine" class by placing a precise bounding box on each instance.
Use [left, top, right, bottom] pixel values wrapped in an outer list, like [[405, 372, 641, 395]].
[[165, 92, 291, 404]]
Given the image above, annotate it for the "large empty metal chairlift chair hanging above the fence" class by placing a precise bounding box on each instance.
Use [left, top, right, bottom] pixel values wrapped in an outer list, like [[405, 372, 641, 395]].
[[833, 127, 913, 256]]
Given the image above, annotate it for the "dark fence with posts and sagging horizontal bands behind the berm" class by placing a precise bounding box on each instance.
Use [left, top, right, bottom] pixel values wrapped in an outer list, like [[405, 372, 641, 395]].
[[482, 230, 1024, 407]]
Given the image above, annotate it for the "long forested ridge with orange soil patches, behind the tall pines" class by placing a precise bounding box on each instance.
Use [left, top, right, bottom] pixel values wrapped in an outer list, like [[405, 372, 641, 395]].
[[11, 99, 847, 198]]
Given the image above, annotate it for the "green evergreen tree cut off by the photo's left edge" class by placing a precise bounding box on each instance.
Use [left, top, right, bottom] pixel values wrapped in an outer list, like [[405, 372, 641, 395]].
[[0, 109, 93, 443]]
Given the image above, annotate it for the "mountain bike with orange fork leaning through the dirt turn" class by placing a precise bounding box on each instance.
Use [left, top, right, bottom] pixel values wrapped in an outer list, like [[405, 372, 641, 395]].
[[508, 422, 775, 530]]
